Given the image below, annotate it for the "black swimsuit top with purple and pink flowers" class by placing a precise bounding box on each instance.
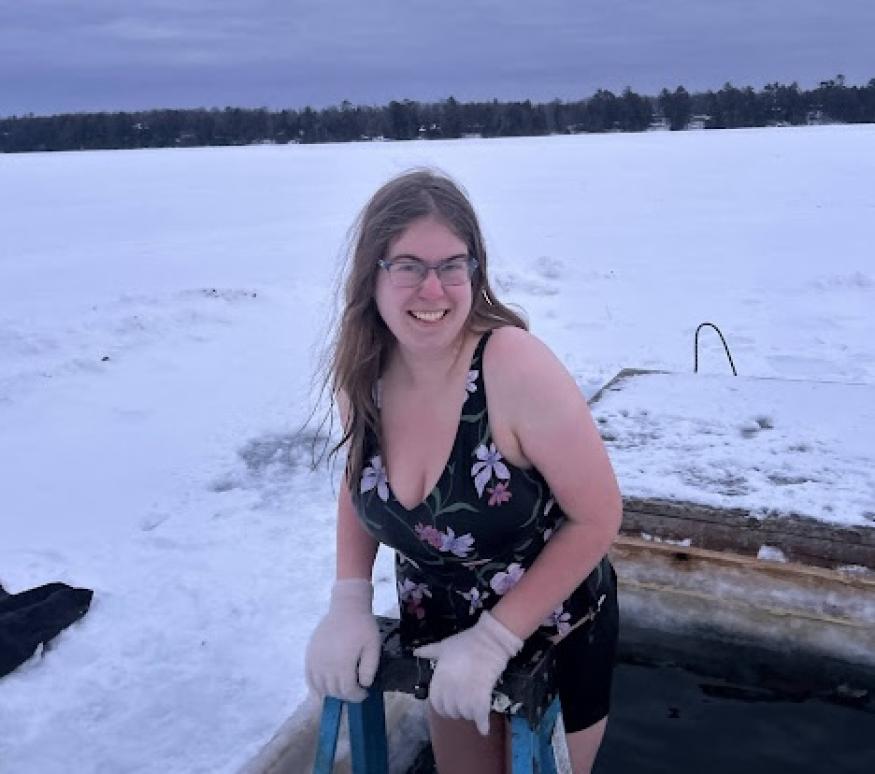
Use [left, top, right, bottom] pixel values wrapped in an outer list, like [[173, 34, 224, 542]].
[[353, 333, 613, 641]]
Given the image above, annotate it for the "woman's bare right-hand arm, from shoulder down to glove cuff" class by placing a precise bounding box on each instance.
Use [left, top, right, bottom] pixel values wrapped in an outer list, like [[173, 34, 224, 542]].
[[484, 328, 622, 639]]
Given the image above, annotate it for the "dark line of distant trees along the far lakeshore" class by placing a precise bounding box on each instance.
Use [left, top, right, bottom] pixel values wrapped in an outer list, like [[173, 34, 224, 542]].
[[0, 75, 875, 153]]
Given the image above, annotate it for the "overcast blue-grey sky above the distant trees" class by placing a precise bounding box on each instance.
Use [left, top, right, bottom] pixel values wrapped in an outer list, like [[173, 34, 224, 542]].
[[0, 0, 875, 116]]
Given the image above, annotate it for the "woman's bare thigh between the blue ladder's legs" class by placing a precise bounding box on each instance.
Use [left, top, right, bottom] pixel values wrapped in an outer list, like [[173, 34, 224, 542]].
[[428, 704, 507, 774]]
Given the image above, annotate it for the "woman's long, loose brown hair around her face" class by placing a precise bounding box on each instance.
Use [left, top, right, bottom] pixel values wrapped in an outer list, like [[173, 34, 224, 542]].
[[322, 169, 528, 488]]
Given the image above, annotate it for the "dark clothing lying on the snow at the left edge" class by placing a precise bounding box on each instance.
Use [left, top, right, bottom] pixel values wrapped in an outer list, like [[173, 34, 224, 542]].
[[0, 583, 94, 677]]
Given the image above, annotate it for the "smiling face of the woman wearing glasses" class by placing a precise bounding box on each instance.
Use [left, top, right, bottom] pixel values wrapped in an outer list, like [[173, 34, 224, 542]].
[[375, 216, 473, 351]]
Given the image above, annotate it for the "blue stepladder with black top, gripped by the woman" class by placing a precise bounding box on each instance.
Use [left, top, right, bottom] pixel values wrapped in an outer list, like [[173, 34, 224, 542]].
[[313, 618, 559, 774]]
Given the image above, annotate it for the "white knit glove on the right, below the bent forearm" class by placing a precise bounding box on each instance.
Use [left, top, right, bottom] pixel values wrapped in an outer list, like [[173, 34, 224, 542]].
[[413, 611, 523, 736]]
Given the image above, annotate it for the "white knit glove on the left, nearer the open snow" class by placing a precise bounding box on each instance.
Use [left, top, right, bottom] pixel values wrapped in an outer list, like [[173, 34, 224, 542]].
[[304, 578, 381, 702]]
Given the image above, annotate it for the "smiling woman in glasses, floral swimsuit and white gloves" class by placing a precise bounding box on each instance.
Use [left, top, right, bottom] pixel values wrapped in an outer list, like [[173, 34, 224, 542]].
[[306, 170, 621, 774]]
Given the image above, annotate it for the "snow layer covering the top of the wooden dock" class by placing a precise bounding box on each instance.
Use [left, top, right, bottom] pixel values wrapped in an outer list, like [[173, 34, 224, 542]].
[[593, 373, 875, 527]]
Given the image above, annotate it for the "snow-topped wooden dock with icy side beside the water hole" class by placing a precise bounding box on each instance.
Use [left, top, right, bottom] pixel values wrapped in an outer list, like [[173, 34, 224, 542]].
[[591, 370, 875, 692]]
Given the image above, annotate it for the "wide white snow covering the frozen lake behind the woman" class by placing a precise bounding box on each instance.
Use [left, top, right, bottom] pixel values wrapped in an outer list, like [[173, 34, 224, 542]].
[[0, 126, 875, 774]]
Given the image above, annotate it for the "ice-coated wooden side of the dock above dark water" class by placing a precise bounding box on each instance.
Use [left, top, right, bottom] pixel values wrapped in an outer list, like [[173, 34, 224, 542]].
[[611, 536, 875, 684]]
